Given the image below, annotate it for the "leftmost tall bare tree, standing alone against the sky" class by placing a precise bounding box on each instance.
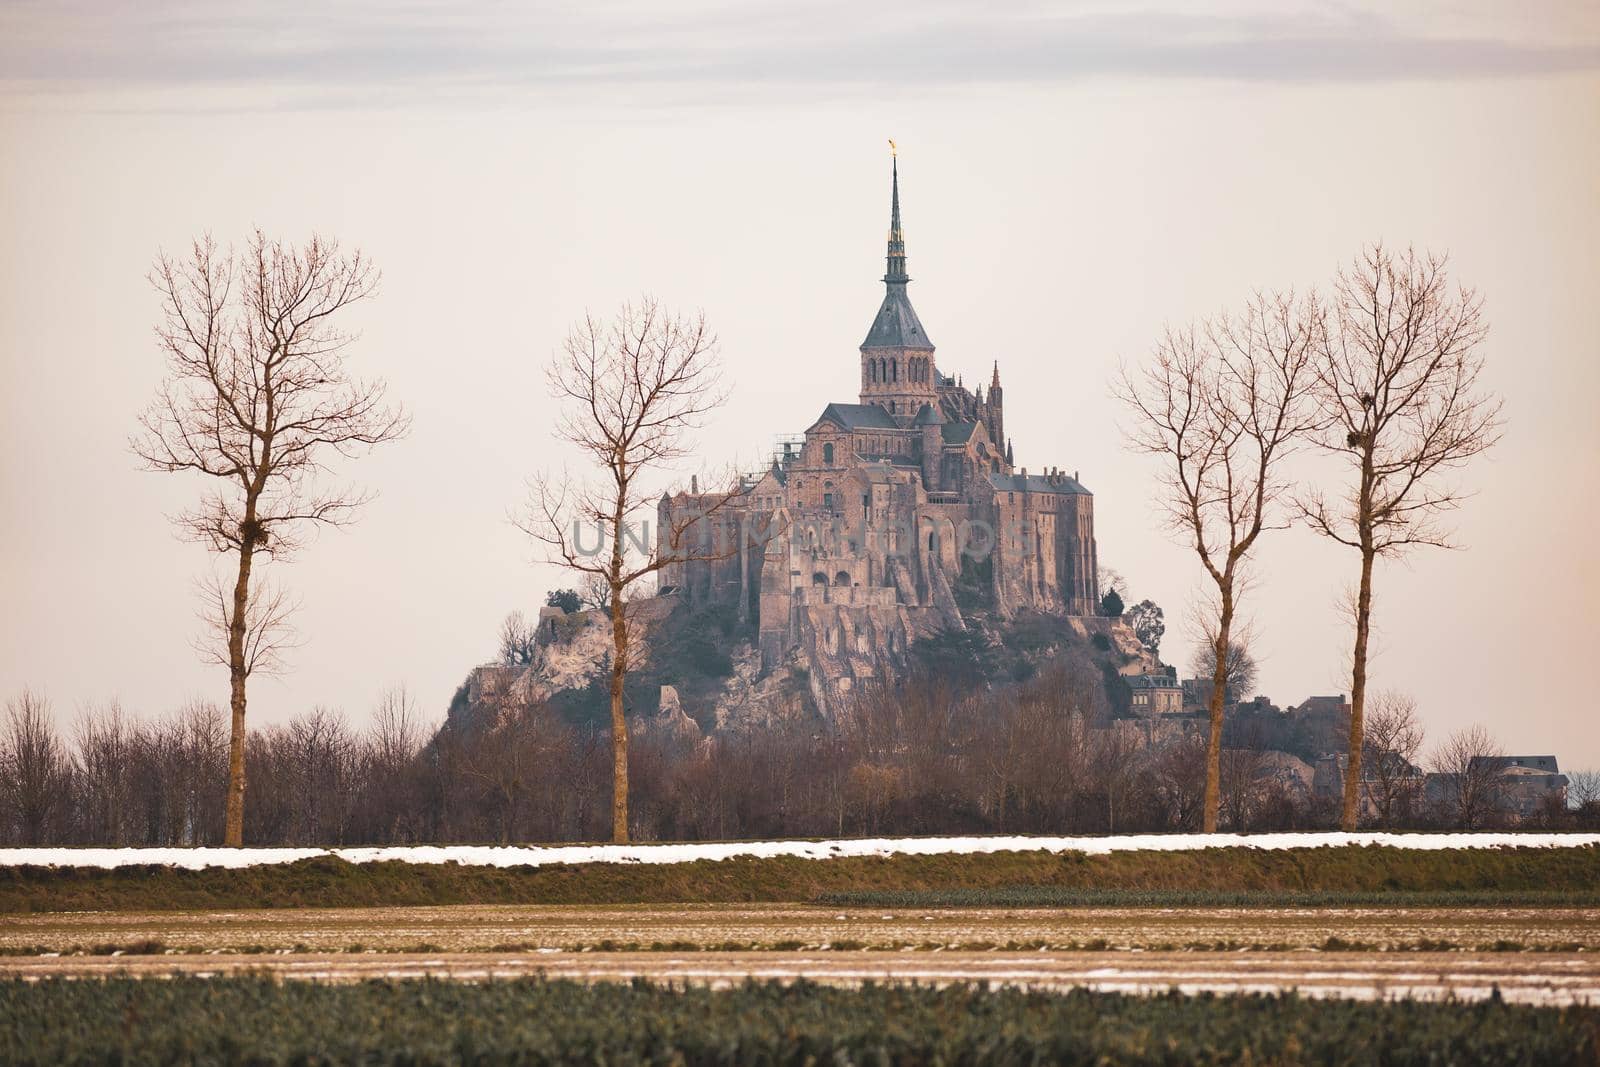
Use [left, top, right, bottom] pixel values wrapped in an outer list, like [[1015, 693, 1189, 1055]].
[[133, 230, 406, 846]]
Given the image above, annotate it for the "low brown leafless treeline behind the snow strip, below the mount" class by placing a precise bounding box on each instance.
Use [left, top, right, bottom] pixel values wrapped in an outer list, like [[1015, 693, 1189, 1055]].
[[0, 675, 1600, 846]]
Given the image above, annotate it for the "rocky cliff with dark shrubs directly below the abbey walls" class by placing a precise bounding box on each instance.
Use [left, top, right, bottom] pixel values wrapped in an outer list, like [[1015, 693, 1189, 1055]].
[[453, 589, 1154, 734]]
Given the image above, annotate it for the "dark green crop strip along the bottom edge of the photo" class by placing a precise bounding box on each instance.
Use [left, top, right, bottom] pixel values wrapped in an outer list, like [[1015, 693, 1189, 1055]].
[[0, 977, 1600, 1067]]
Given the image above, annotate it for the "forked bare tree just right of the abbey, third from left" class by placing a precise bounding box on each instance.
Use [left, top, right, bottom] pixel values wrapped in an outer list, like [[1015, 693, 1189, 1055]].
[[1118, 294, 1323, 833]]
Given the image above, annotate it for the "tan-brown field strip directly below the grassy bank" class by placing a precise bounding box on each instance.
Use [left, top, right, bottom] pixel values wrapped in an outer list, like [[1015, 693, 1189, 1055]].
[[0, 904, 1600, 960]]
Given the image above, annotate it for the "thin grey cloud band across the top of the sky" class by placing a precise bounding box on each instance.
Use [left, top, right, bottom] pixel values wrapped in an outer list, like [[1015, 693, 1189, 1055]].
[[0, 0, 1600, 102]]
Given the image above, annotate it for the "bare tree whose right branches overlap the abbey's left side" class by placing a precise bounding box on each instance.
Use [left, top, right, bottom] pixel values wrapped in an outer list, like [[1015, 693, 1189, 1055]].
[[518, 299, 739, 841]]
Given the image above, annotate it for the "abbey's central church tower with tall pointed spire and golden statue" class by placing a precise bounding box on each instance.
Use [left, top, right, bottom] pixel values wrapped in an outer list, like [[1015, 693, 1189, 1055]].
[[861, 151, 939, 426]]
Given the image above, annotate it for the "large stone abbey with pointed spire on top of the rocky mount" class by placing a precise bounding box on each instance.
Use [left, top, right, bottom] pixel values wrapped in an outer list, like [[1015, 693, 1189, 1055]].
[[658, 151, 1099, 691]]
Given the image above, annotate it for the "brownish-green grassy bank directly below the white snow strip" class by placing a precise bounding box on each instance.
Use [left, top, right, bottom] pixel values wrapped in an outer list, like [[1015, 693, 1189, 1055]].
[[0, 846, 1600, 912]]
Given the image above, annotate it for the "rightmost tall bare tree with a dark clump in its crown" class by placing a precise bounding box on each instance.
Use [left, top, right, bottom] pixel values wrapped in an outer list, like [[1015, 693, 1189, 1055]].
[[1301, 245, 1501, 830]]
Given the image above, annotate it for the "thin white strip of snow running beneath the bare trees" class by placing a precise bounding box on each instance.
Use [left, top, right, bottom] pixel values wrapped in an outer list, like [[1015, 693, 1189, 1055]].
[[0, 833, 1600, 870]]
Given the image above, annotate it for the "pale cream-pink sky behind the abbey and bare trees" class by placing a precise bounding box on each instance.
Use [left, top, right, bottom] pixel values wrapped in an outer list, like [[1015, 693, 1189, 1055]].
[[0, 0, 1600, 768]]
